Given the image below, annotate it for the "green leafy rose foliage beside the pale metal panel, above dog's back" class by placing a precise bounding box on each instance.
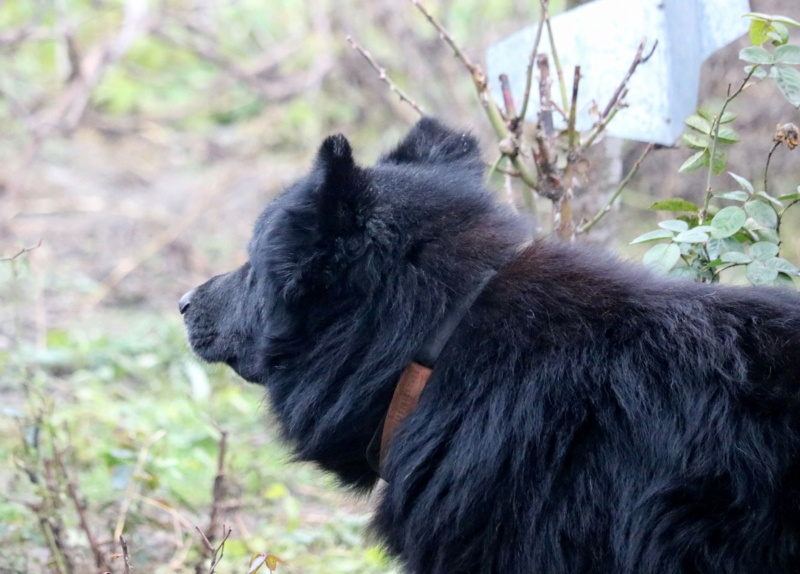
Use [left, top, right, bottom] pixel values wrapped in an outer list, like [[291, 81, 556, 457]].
[[631, 13, 800, 288]]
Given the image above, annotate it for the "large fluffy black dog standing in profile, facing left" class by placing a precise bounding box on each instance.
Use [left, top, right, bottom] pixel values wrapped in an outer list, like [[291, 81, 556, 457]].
[[181, 119, 800, 574]]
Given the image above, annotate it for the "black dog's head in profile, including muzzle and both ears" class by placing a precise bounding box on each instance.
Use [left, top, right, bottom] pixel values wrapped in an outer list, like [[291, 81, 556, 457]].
[[180, 118, 528, 382]]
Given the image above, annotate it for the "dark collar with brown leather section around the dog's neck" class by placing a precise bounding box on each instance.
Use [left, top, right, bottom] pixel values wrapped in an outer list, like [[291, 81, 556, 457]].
[[367, 270, 497, 476]]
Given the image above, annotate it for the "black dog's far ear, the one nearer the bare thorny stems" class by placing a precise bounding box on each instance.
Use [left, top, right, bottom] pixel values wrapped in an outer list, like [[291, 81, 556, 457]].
[[379, 117, 481, 165]]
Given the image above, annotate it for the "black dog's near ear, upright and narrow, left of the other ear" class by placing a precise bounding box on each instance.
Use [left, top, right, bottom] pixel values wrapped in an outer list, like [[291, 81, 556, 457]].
[[314, 134, 375, 236]]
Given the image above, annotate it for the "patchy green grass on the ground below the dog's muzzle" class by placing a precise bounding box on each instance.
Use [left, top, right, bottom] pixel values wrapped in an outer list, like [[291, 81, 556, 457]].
[[0, 294, 392, 574]]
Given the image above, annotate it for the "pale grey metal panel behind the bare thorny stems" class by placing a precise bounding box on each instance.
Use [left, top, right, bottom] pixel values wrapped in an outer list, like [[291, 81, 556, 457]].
[[487, 0, 750, 145]]
